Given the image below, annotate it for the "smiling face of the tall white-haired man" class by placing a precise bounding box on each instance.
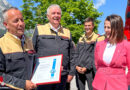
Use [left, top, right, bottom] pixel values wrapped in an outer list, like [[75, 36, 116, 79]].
[[47, 6, 61, 26]]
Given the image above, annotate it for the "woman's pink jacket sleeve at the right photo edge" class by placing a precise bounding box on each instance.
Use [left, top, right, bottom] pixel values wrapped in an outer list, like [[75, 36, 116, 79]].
[[125, 42, 130, 85]]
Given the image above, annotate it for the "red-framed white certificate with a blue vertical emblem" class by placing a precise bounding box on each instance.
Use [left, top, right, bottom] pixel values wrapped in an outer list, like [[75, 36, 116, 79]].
[[31, 54, 63, 85]]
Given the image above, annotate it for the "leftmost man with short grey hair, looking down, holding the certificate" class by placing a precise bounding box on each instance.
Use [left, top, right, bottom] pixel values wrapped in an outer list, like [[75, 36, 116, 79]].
[[0, 7, 36, 90]]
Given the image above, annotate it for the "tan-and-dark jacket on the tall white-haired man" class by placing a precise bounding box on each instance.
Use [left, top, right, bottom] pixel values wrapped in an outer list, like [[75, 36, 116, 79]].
[[32, 24, 74, 75]]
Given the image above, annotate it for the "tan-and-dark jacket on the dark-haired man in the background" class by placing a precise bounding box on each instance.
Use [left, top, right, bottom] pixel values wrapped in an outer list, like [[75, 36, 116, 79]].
[[75, 32, 99, 73]]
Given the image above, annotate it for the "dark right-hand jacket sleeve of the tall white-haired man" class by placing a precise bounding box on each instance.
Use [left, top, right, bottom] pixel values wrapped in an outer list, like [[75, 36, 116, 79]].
[[69, 34, 76, 76]]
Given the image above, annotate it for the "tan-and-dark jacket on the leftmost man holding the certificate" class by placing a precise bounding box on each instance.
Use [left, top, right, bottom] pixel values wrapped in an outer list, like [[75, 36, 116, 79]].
[[0, 32, 34, 89]]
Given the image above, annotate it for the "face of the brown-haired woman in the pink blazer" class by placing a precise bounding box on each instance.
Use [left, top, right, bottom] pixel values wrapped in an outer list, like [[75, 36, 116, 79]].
[[104, 20, 111, 39]]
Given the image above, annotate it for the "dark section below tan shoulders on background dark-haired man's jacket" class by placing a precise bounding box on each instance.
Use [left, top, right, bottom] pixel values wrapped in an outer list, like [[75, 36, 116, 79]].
[[76, 42, 95, 70]]
